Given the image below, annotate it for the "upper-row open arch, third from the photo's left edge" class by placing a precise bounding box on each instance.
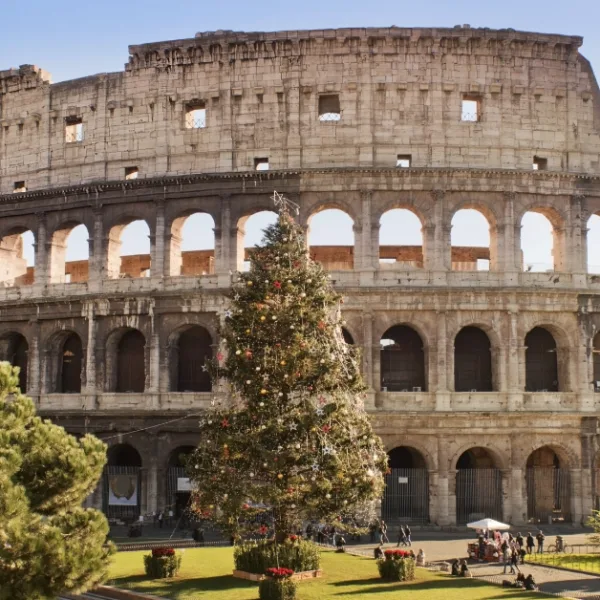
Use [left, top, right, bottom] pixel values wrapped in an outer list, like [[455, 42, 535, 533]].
[[106, 220, 150, 279]]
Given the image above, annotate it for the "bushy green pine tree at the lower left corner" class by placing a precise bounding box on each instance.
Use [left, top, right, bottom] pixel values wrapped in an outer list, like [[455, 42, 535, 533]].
[[0, 363, 112, 600]]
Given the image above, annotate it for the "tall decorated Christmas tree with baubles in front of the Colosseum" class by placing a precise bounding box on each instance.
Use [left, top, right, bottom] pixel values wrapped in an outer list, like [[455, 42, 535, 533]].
[[188, 193, 387, 540]]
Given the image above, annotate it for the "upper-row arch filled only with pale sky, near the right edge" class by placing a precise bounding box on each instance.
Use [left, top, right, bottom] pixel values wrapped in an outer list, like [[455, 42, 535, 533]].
[[521, 211, 555, 273]]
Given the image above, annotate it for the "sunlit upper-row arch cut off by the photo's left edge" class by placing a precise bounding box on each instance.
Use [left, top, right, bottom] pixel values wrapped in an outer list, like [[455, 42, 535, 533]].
[[0, 228, 35, 287]]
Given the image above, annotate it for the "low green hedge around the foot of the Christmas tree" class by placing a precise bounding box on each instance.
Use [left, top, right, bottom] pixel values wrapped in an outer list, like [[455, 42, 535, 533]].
[[233, 539, 321, 574]]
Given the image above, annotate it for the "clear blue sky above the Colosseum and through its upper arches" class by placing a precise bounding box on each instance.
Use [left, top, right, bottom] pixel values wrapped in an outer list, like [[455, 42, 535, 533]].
[[0, 0, 600, 270]]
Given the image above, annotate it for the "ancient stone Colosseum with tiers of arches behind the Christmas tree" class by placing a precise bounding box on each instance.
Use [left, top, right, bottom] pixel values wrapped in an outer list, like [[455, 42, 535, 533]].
[[0, 26, 600, 526]]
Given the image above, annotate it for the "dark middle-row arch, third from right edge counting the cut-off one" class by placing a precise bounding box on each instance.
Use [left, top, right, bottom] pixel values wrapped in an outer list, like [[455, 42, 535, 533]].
[[454, 327, 494, 392]]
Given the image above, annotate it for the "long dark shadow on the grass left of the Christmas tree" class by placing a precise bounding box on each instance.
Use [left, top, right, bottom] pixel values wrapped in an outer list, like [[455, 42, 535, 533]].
[[110, 575, 258, 593]]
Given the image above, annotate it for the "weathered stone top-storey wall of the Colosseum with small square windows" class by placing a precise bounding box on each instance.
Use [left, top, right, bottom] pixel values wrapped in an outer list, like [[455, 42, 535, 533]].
[[0, 28, 600, 192]]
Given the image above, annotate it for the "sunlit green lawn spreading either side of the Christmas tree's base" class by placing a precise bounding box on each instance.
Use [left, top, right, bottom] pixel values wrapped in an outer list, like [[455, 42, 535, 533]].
[[108, 548, 540, 600]]
